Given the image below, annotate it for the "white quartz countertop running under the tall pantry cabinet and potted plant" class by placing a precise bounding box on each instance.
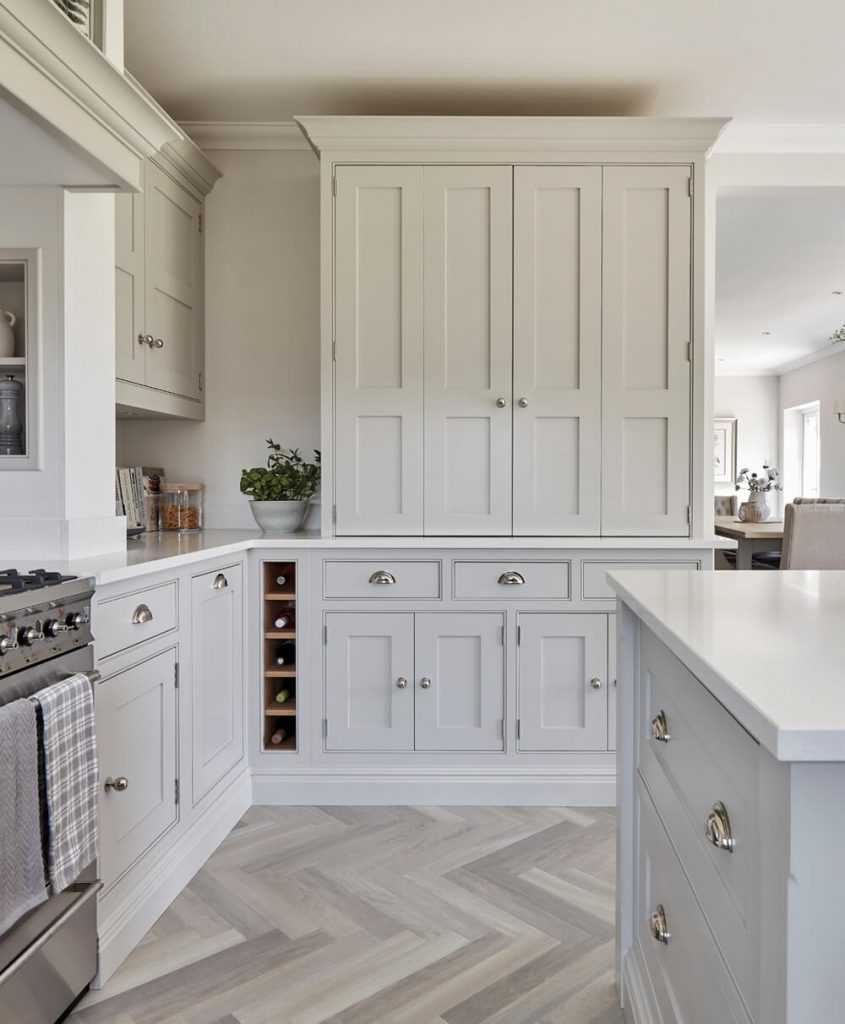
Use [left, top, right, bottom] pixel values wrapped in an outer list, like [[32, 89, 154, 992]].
[[56, 529, 720, 584]]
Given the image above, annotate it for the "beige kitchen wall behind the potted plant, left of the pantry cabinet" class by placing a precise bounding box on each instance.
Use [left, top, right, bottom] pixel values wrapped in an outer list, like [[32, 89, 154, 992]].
[[118, 151, 320, 528]]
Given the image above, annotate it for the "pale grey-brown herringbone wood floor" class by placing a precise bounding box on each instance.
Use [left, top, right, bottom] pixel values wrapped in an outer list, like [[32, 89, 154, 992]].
[[70, 807, 623, 1024]]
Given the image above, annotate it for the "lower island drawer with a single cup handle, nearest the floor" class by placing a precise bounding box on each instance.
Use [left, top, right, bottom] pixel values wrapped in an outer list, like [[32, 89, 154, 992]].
[[635, 784, 751, 1024]]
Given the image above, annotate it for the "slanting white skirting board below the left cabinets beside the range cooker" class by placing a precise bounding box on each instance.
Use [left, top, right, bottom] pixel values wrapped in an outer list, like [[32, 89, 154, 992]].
[[91, 769, 250, 988]]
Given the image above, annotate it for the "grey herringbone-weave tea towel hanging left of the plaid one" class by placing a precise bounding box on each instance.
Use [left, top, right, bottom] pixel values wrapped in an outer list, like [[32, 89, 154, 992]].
[[0, 698, 47, 935]]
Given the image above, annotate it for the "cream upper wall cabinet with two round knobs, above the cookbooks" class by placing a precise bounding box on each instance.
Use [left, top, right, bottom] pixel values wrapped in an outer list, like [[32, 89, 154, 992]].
[[115, 152, 214, 419]]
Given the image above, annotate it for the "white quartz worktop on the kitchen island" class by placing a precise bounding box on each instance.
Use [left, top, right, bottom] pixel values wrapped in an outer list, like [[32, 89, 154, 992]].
[[608, 570, 845, 761]]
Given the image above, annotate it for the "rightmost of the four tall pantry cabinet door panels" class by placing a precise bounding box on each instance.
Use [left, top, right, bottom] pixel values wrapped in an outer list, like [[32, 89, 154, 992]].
[[601, 166, 691, 537]]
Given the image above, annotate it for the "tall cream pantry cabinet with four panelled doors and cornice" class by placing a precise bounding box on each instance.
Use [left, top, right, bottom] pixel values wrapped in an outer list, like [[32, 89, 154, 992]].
[[299, 118, 724, 537]]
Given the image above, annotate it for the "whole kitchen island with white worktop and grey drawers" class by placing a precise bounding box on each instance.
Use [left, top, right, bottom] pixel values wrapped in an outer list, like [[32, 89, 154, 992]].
[[610, 571, 845, 1024]]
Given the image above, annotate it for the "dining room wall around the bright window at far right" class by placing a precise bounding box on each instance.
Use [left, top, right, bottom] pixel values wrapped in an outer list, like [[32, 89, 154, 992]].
[[778, 352, 845, 500]]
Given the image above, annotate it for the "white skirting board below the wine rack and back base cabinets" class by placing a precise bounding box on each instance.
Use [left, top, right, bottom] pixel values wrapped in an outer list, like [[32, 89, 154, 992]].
[[252, 768, 617, 807]]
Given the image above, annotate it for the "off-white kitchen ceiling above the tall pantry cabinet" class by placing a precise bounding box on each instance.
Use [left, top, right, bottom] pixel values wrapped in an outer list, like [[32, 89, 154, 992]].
[[125, 0, 845, 123]]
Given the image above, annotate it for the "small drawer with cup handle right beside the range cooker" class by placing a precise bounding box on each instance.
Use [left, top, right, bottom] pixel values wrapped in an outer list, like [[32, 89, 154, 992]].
[[94, 580, 178, 659]]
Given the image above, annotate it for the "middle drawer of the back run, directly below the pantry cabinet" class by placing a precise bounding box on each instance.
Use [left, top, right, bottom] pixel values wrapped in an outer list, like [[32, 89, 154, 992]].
[[454, 561, 569, 601]]
